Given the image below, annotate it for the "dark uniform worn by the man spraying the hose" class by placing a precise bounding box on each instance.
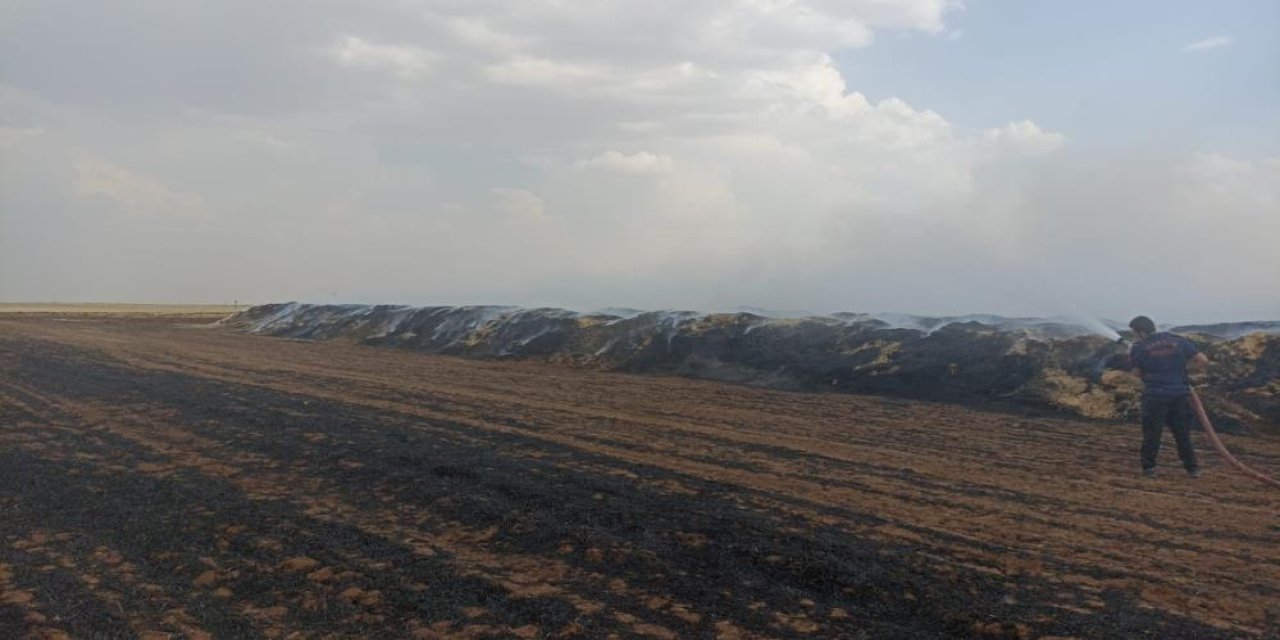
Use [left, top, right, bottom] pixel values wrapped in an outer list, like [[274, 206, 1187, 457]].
[[1129, 332, 1198, 474]]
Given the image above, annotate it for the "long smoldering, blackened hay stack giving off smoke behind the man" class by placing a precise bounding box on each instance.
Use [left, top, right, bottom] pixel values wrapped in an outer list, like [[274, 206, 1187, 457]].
[[221, 302, 1280, 433]]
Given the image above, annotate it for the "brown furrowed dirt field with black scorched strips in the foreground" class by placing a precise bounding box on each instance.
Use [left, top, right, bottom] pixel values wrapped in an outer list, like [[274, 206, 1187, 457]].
[[0, 316, 1280, 639]]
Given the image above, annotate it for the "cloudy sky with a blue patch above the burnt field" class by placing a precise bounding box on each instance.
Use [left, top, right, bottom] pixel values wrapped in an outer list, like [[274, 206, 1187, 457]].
[[0, 0, 1280, 323]]
